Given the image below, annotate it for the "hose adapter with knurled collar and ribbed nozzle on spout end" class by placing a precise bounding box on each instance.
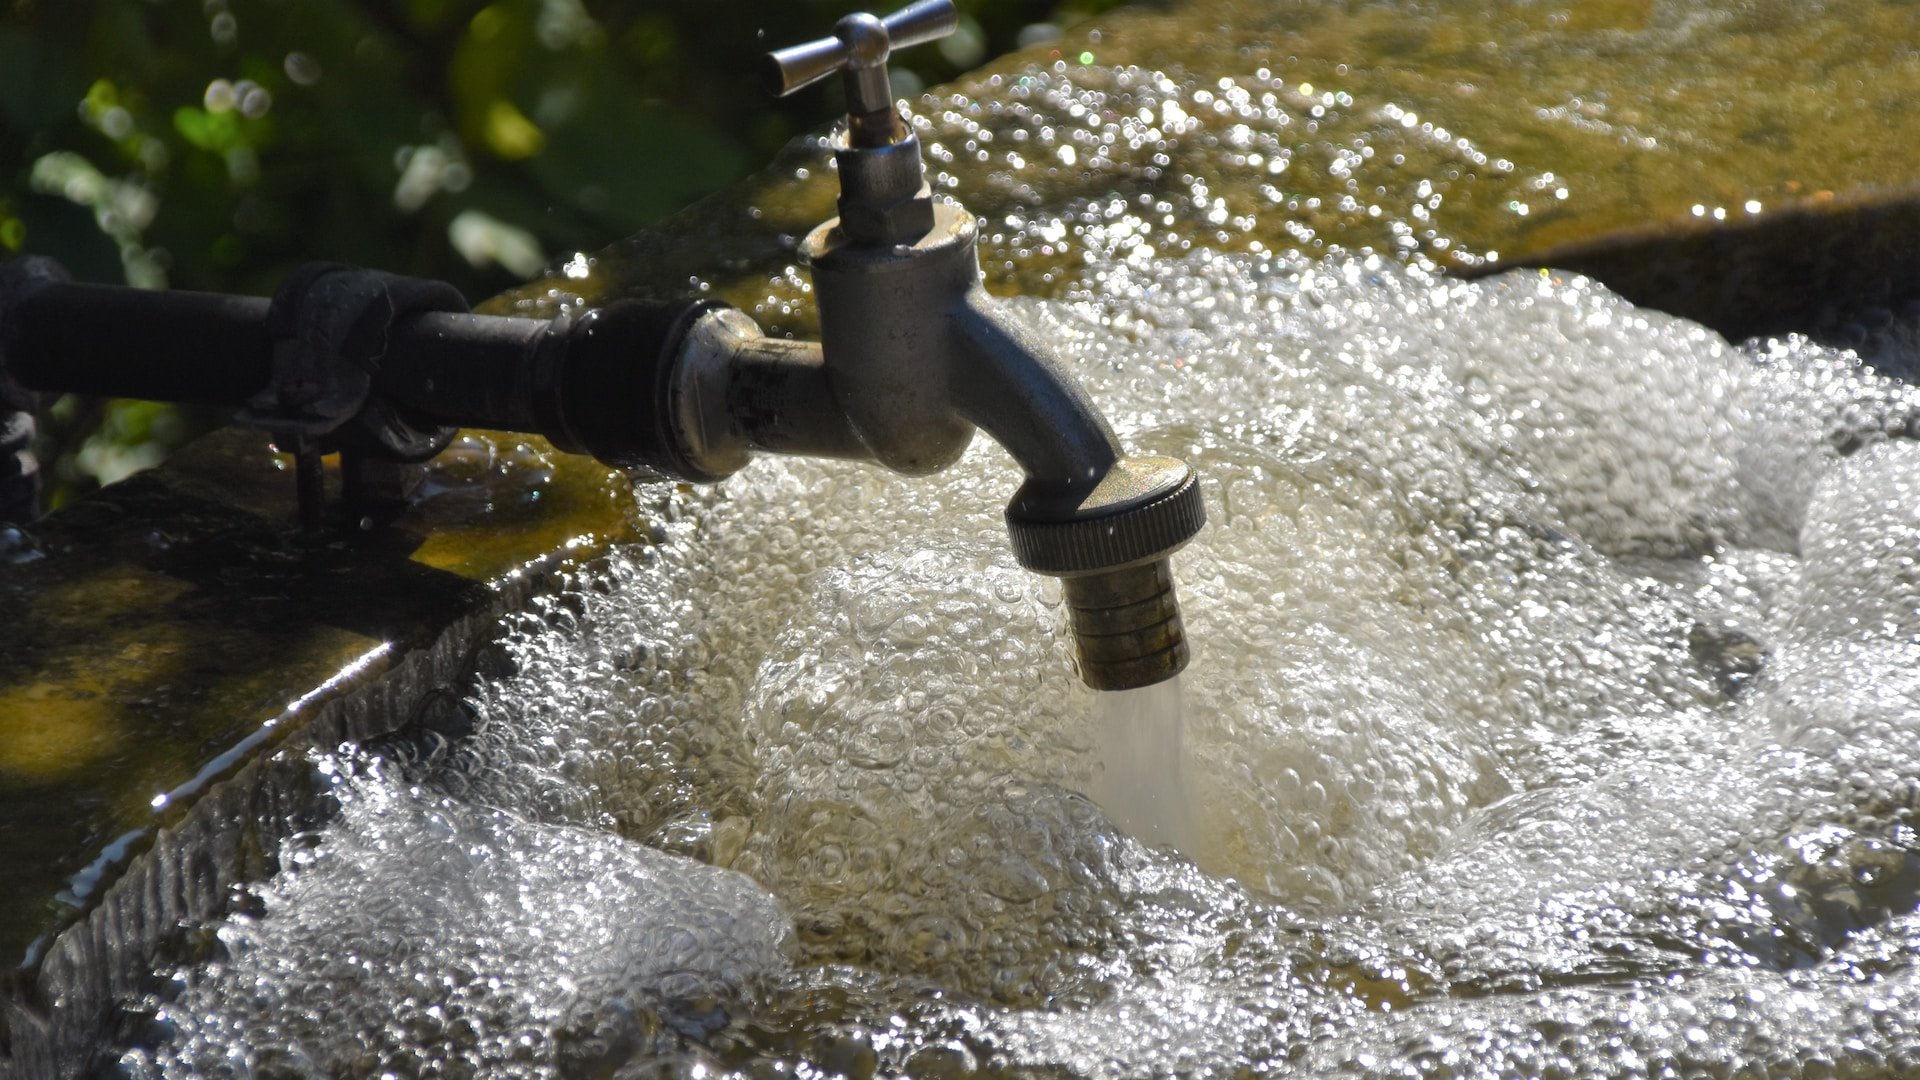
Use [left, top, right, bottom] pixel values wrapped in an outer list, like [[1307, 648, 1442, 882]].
[[1006, 457, 1206, 690]]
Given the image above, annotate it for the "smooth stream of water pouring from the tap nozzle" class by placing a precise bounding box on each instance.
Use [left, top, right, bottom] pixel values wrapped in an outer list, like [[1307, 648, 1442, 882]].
[[1091, 678, 1200, 855]]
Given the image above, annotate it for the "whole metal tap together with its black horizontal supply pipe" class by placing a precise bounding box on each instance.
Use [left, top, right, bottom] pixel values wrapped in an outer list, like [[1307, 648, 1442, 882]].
[[0, 0, 1206, 690]]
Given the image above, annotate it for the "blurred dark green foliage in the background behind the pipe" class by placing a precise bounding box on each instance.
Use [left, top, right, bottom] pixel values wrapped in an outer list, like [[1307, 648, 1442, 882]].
[[0, 0, 1117, 507]]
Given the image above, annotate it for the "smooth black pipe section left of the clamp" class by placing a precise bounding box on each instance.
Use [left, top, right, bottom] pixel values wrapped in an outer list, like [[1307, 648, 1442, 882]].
[[4, 282, 273, 407]]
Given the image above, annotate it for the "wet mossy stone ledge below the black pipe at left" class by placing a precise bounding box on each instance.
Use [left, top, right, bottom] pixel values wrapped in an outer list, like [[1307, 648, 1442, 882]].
[[0, 429, 636, 963]]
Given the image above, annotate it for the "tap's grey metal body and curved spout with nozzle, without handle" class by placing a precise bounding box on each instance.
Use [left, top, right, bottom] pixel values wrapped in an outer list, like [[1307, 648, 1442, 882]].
[[779, 184, 1206, 690]]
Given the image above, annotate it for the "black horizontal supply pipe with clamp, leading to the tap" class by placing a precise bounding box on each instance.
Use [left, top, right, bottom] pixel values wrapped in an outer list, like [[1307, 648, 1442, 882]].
[[0, 259, 725, 480]]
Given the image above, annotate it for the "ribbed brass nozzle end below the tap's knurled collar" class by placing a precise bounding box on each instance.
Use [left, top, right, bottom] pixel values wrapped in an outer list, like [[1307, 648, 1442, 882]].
[[1062, 559, 1188, 690]]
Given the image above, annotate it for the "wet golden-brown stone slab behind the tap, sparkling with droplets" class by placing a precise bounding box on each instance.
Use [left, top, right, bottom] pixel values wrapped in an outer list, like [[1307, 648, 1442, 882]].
[[501, 0, 1920, 356]]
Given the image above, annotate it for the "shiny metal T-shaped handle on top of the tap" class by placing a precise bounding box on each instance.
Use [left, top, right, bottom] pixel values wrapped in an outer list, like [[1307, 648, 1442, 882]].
[[766, 0, 960, 144]]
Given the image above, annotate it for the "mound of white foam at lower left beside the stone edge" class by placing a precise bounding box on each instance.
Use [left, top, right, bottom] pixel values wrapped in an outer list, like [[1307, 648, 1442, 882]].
[[136, 759, 791, 1076]]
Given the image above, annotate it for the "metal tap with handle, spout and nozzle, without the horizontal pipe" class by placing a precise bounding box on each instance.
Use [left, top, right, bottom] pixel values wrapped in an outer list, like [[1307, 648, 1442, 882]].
[[741, 0, 1206, 690]]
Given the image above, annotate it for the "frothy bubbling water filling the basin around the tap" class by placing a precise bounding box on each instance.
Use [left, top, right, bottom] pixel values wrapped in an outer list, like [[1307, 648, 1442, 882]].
[[127, 256, 1920, 1076]]
